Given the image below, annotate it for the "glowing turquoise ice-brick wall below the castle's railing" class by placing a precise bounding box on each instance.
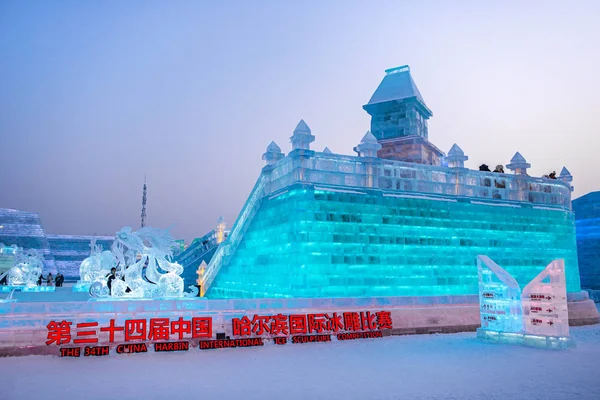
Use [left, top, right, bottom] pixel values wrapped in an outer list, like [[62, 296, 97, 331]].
[[208, 184, 580, 298]]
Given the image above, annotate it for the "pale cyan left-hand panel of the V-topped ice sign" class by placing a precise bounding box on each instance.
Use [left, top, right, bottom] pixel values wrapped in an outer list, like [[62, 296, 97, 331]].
[[477, 256, 523, 332]]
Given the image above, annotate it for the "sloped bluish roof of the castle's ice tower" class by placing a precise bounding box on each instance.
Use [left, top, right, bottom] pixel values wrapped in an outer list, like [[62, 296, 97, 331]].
[[367, 65, 431, 115]]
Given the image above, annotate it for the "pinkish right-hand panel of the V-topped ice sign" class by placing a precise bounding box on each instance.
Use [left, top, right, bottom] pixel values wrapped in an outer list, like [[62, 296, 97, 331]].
[[522, 260, 569, 336]]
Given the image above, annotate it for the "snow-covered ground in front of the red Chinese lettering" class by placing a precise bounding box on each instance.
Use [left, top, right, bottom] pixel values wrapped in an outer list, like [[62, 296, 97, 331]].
[[0, 325, 600, 400]]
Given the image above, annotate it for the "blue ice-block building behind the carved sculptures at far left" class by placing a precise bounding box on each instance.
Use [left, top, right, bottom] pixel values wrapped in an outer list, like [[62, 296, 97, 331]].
[[0, 208, 114, 281]]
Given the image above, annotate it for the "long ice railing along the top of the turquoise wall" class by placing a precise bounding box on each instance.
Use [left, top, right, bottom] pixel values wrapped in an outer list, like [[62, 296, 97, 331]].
[[269, 153, 571, 209]]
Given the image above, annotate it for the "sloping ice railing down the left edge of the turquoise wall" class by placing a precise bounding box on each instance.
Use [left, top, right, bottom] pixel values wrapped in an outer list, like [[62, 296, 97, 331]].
[[200, 174, 267, 297]]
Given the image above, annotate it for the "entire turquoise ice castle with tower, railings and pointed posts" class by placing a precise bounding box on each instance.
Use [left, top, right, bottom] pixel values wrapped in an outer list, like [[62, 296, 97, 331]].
[[199, 66, 581, 298]]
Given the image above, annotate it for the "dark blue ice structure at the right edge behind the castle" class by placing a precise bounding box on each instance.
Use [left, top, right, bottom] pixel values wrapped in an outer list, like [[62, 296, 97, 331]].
[[573, 192, 600, 301]]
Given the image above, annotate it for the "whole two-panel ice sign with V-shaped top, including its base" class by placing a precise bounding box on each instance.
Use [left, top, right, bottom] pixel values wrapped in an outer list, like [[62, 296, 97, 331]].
[[477, 255, 575, 349]]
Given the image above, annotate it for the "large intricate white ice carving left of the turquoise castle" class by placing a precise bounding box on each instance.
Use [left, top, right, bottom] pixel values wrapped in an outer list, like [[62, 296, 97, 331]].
[[81, 227, 198, 299]]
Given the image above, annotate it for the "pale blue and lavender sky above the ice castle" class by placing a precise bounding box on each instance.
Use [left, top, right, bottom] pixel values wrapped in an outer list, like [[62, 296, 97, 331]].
[[0, 0, 600, 240]]
